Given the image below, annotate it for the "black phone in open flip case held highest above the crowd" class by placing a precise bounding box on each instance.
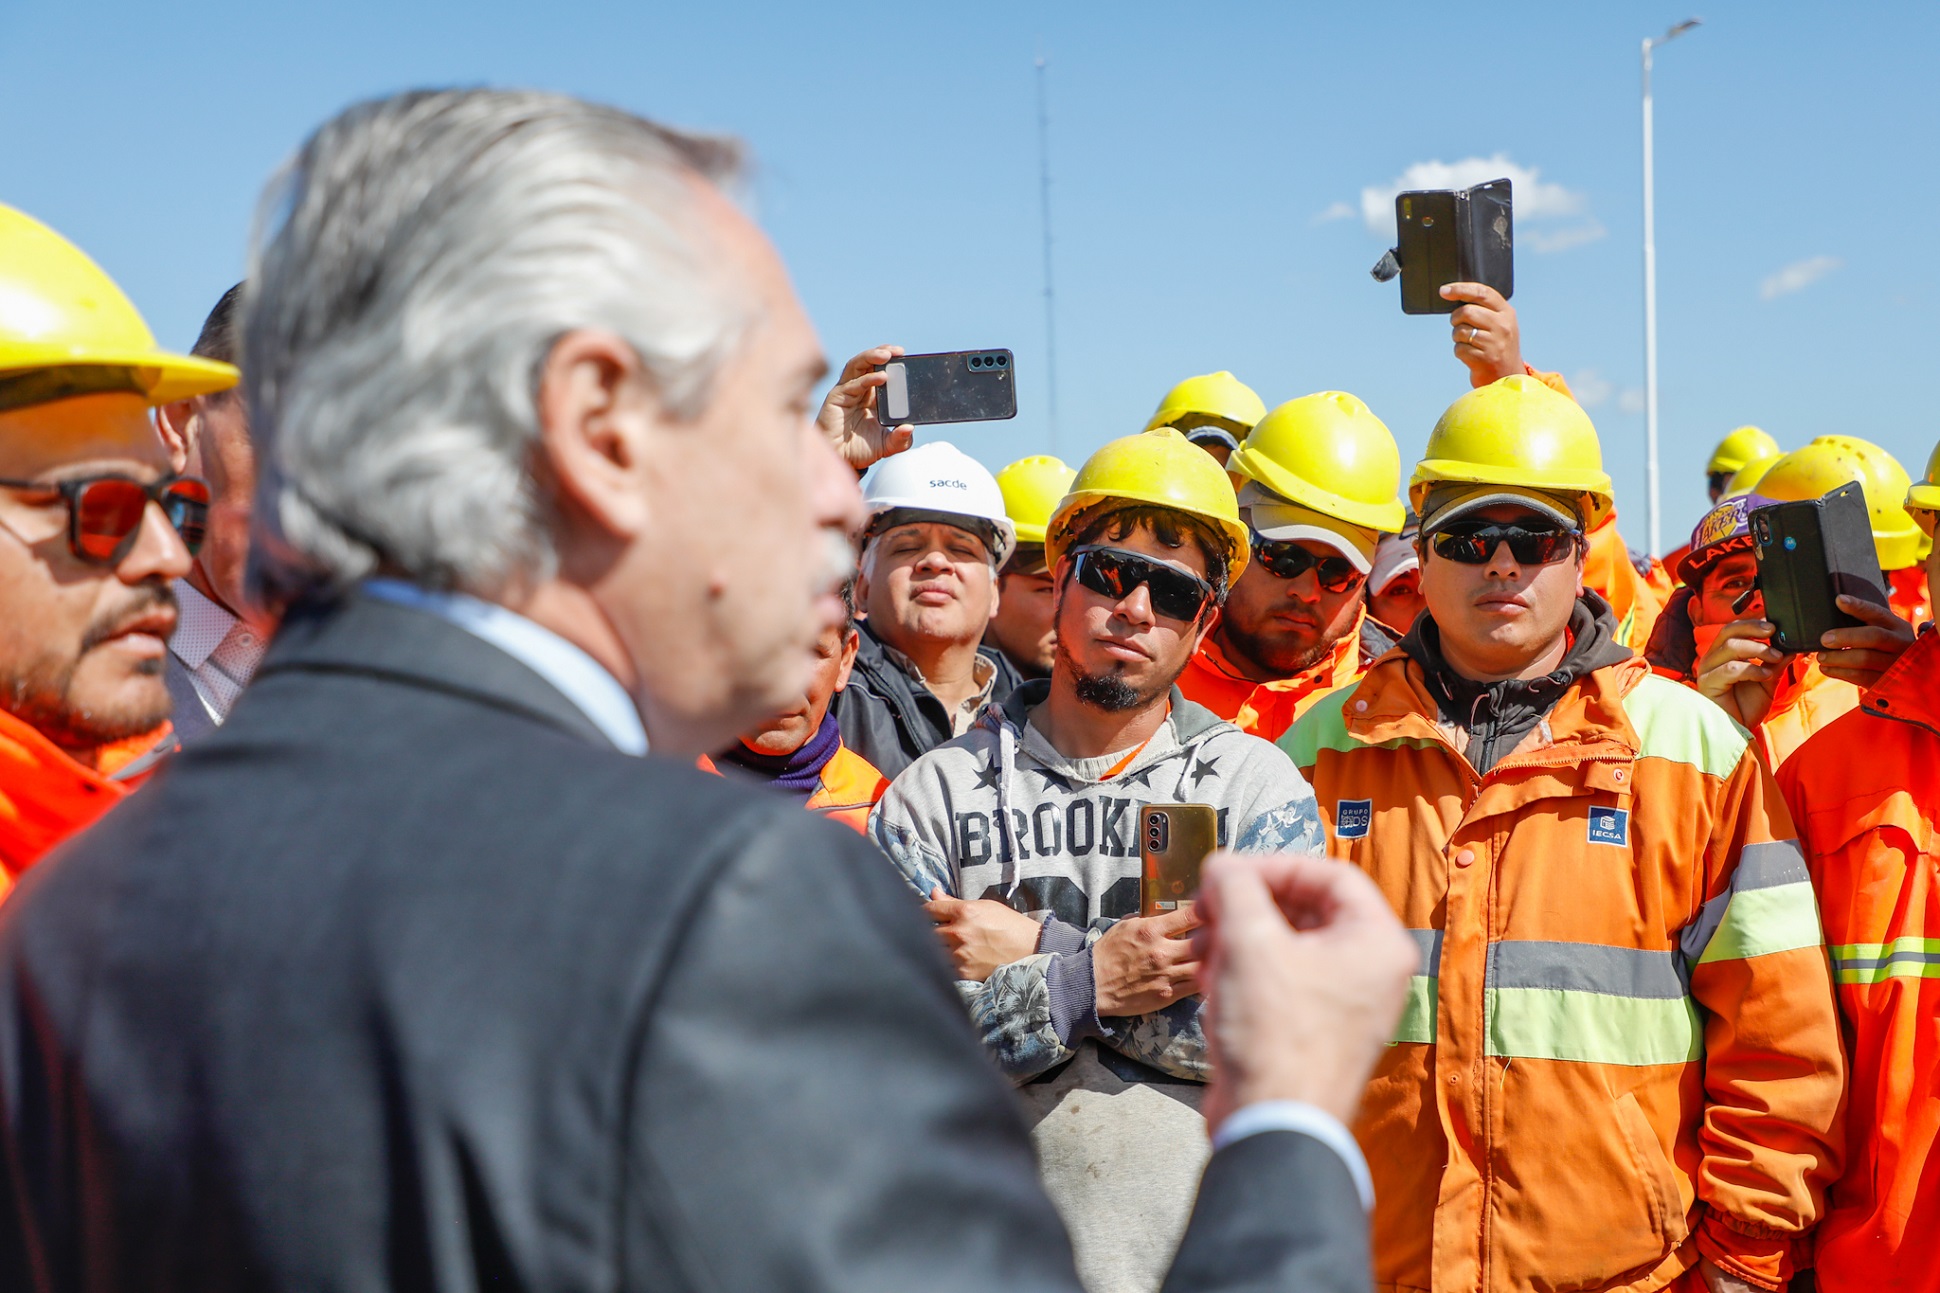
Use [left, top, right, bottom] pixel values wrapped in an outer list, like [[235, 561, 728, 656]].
[[1395, 179, 1515, 315]]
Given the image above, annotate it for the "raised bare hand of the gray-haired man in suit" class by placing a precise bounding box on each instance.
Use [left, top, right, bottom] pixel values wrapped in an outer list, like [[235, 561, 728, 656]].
[[1197, 852, 1420, 1130]]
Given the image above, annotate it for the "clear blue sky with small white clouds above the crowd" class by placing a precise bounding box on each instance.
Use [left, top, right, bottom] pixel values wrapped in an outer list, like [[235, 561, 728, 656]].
[[0, 0, 1940, 546]]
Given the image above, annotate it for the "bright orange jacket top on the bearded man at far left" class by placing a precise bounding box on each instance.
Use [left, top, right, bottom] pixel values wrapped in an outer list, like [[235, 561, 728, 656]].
[[0, 711, 175, 897]]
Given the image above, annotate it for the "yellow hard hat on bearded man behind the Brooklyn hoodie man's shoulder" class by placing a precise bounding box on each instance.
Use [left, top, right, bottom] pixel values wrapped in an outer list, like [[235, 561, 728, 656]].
[[1226, 390, 1408, 534]]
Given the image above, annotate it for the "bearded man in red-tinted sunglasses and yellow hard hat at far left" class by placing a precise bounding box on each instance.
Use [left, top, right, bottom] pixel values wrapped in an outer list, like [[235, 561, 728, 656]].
[[0, 206, 237, 893]]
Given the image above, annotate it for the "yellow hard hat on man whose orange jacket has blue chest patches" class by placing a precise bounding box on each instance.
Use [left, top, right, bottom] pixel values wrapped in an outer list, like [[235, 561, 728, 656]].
[[1408, 373, 1616, 530]]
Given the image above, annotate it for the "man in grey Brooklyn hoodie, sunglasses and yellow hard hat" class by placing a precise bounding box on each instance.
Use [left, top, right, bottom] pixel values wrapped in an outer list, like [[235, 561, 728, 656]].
[[871, 427, 1321, 1289]]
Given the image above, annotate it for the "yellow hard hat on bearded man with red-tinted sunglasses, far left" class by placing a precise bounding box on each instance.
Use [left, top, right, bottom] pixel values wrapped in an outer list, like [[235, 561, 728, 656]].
[[0, 206, 241, 408]]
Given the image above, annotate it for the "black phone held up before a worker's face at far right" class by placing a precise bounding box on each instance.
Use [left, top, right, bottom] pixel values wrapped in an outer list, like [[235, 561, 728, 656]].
[[1752, 483, 1888, 652]]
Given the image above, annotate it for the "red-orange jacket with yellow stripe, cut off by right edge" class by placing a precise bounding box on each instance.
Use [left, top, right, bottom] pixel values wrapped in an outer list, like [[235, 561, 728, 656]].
[[1779, 633, 1940, 1293]]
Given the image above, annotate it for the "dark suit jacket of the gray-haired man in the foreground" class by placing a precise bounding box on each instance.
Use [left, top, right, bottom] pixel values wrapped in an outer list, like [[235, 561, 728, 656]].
[[0, 598, 1368, 1293]]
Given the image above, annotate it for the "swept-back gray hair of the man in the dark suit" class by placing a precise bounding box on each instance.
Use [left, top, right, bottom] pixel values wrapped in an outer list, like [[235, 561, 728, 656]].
[[243, 89, 753, 604]]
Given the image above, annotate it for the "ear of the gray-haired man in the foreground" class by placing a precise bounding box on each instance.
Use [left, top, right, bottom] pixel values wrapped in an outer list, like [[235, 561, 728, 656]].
[[537, 328, 660, 538]]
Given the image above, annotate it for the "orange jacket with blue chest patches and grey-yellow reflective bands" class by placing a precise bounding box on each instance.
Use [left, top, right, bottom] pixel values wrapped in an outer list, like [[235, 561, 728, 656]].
[[1280, 652, 1843, 1291]]
